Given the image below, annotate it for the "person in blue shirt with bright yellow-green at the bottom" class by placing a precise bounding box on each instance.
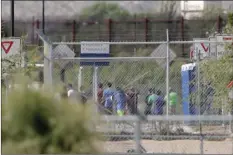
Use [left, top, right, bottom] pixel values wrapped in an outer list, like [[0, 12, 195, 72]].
[[114, 87, 126, 116]]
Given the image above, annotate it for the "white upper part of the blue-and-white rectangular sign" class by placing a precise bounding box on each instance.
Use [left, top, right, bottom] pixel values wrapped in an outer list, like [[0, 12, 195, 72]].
[[81, 41, 109, 54]]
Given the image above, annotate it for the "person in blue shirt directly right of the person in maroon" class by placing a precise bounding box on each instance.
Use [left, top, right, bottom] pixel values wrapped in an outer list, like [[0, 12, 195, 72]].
[[103, 82, 115, 115]]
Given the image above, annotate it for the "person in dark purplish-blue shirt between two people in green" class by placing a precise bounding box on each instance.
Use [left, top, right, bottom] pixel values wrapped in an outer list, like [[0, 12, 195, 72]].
[[152, 90, 165, 115]]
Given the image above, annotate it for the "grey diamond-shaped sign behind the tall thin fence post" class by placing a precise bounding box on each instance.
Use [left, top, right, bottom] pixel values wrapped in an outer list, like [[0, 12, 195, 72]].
[[150, 44, 176, 68]]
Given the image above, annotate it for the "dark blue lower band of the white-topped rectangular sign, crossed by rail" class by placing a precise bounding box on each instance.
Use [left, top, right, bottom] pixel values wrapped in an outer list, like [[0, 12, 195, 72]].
[[80, 53, 109, 66]]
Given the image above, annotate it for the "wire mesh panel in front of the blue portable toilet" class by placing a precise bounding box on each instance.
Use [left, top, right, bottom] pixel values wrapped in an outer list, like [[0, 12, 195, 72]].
[[169, 40, 232, 119]]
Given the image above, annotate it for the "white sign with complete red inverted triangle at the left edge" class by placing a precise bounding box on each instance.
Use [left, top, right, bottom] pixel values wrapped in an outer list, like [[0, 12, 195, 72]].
[[1, 38, 21, 58]]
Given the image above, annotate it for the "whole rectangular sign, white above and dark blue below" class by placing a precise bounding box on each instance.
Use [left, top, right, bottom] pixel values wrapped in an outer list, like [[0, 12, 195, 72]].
[[80, 41, 110, 66]]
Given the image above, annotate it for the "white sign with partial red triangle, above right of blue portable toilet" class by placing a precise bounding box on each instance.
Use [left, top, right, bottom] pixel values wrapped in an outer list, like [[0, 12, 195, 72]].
[[193, 38, 209, 60]]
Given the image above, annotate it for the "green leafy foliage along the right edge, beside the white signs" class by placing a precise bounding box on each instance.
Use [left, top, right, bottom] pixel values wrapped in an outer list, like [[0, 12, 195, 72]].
[[201, 13, 233, 110]]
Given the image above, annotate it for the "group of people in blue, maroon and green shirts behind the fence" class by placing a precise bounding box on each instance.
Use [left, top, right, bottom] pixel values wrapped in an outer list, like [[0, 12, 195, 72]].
[[97, 82, 177, 116]]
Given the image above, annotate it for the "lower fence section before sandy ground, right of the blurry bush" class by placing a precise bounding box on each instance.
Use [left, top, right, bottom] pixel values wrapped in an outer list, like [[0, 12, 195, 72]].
[[97, 115, 233, 154]]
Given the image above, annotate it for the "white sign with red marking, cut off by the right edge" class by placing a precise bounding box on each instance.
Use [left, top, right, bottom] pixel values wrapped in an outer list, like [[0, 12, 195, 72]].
[[216, 35, 233, 58]]
